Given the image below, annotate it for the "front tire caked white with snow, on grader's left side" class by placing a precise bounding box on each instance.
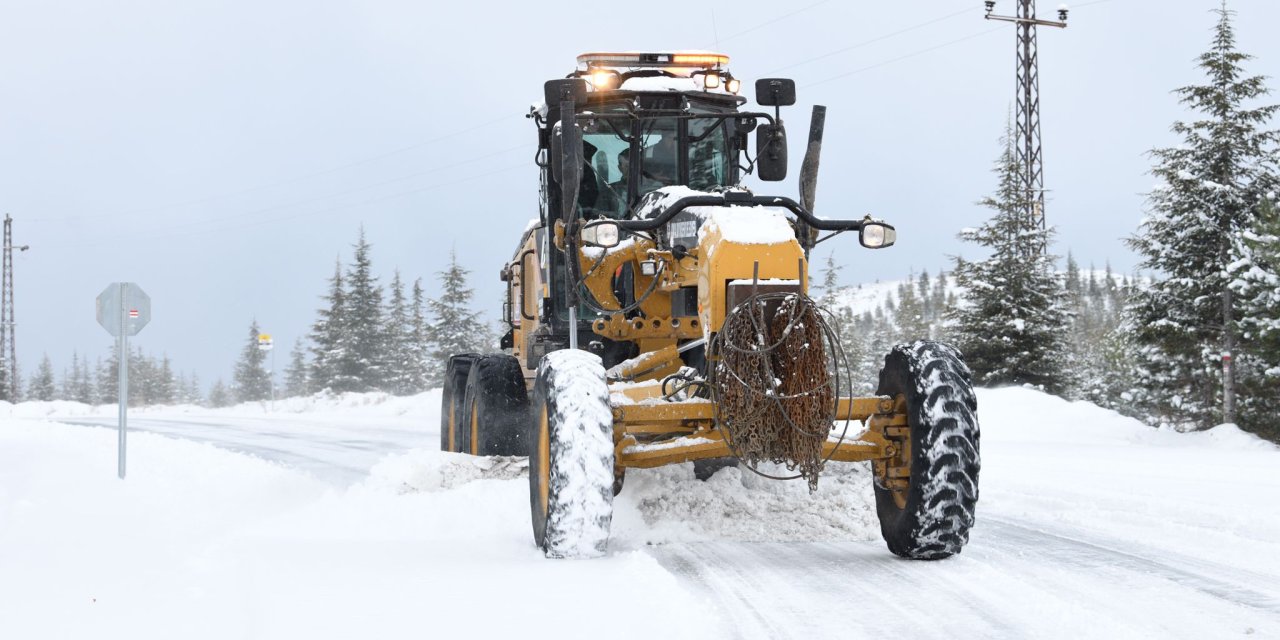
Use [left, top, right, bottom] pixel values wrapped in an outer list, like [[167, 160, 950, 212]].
[[529, 349, 614, 558]]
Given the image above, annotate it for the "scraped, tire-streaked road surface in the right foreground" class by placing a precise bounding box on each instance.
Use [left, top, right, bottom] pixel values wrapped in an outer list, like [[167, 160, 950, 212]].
[[645, 518, 1280, 640]]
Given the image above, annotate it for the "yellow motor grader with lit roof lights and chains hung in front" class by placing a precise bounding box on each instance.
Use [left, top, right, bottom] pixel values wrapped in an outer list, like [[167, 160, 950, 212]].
[[440, 52, 979, 559]]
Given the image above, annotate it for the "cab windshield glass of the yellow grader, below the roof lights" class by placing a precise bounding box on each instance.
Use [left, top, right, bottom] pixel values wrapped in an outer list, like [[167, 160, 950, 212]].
[[579, 109, 732, 219]]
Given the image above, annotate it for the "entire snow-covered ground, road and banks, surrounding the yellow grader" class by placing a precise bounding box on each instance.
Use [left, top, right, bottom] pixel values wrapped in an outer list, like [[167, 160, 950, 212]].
[[0, 389, 1280, 639]]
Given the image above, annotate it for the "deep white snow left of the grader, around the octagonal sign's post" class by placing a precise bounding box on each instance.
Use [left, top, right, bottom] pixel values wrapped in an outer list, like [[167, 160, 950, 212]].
[[0, 417, 718, 640]]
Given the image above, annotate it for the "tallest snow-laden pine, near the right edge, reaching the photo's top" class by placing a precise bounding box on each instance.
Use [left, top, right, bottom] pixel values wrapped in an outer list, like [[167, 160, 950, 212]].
[[1126, 3, 1277, 429]]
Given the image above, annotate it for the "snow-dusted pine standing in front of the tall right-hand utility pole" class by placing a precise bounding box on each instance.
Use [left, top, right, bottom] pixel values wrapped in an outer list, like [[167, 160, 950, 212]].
[[951, 122, 1070, 394]]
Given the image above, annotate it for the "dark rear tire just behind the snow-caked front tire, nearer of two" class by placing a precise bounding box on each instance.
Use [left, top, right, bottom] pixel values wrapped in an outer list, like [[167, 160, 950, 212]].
[[460, 355, 529, 456]]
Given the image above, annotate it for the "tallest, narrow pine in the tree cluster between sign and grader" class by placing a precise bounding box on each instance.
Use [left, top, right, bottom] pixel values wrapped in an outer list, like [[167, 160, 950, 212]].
[[333, 227, 387, 392]]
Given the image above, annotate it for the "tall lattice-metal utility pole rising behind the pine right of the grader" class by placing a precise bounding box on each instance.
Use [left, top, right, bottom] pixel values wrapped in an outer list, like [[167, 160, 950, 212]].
[[984, 0, 1068, 255]]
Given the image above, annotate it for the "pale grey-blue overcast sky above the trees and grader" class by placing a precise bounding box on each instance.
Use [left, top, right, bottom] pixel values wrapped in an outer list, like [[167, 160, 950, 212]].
[[0, 0, 1280, 384]]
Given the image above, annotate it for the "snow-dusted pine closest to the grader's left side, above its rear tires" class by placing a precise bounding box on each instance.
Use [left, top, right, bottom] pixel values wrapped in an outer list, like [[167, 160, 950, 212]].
[[428, 251, 493, 387]]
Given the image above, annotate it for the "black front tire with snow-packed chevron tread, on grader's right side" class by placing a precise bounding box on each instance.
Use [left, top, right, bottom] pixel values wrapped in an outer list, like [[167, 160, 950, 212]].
[[876, 340, 982, 559]]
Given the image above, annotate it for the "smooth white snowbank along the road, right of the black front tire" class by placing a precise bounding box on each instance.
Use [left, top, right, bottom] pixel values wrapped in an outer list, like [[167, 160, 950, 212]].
[[974, 388, 1280, 575]]
